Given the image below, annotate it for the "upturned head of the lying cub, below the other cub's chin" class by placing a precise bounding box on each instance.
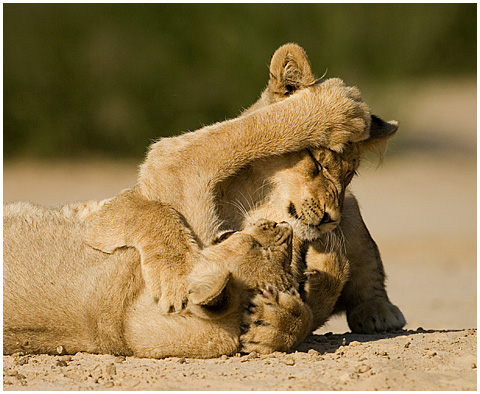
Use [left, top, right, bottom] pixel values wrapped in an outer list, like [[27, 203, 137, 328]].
[[189, 220, 298, 318]]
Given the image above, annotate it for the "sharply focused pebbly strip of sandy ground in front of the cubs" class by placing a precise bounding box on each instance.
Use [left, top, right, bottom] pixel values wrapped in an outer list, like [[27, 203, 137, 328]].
[[3, 330, 477, 391]]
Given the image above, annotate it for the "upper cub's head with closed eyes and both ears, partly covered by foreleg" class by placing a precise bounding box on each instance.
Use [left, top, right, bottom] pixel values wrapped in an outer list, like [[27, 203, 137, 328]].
[[236, 44, 398, 241]]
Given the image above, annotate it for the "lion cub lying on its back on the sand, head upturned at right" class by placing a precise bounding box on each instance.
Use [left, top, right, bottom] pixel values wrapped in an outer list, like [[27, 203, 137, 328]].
[[3, 202, 312, 358]]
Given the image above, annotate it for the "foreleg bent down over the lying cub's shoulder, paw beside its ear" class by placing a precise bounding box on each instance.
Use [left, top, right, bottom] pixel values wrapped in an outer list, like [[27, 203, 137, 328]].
[[85, 189, 200, 313]]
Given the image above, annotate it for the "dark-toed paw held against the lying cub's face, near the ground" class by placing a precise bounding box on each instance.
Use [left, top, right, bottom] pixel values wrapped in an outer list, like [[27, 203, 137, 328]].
[[240, 287, 312, 354]]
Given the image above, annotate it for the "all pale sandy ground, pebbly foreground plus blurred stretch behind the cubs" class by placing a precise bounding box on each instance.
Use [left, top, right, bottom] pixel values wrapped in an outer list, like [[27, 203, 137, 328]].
[[3, 78, 477, 390]]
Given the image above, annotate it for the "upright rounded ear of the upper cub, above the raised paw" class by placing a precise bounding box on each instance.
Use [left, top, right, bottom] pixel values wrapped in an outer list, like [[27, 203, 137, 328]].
[[268, 44, 315, 96]]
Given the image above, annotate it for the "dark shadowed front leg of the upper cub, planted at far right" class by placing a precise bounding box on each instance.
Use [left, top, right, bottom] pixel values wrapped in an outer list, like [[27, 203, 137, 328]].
[[338, 194, 405, 333]]
